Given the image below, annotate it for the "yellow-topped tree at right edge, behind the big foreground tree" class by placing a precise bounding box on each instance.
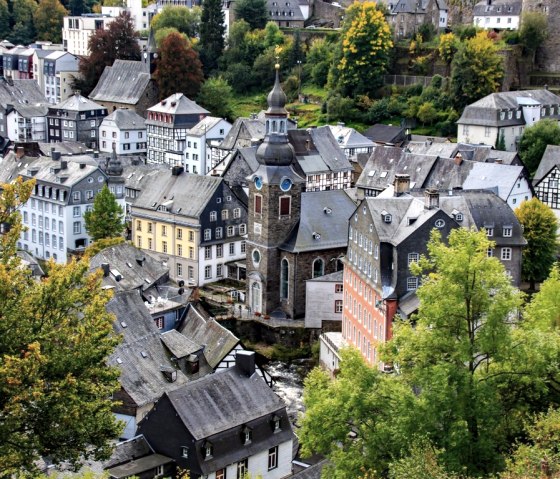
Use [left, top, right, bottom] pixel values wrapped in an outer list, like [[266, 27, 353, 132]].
[[515, 197, 559, 291]]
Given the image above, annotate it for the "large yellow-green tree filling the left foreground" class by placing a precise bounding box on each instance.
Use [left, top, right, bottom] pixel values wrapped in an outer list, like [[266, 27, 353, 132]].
[[0, 179, 121, 477]]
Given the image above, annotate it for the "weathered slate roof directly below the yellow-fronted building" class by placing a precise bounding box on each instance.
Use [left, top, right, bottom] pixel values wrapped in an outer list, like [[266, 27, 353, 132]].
[[90, 243, 169, 291]]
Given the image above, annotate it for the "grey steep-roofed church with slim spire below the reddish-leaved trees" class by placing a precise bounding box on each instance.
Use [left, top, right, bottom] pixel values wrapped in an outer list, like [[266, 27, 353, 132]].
[[89, 35, 159, 117]]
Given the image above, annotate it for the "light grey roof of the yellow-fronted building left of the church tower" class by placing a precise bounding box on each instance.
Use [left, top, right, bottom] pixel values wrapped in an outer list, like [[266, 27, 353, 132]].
[[133, 170, 223, 218]]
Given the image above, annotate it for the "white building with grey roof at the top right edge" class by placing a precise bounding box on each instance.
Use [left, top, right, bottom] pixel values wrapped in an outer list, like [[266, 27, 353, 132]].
[[473, 0, 522, 30]]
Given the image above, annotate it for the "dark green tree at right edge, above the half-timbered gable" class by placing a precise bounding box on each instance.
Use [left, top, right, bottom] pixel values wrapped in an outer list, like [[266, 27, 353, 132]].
[[519, 120, 560, 176]]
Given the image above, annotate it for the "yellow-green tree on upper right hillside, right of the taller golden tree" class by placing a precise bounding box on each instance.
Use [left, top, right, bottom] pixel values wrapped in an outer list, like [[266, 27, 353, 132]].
[[451, 31, 503, 109]]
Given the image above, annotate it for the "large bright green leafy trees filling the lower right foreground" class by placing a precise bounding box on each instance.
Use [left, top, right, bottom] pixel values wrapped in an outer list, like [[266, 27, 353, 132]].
[[300, 228, 560, 479]]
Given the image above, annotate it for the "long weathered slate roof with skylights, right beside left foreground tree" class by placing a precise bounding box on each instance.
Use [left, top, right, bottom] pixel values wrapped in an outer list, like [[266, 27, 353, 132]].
[[107, 291, 187, 407]]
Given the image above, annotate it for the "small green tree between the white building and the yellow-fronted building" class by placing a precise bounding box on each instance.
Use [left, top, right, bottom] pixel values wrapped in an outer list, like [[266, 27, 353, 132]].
[[84, 185, 124, 241]]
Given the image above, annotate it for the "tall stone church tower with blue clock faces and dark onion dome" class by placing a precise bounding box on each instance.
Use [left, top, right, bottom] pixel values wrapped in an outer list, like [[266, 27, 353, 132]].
[[247, 64, 305, 316]]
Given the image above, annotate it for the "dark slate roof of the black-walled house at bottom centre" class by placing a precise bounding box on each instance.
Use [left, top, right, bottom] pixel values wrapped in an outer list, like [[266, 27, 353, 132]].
[[167, 367, 291, 440]]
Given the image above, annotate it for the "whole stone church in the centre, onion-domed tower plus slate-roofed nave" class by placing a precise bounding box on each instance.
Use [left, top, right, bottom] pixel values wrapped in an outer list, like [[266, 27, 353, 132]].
[[247, 70, 355, 318]]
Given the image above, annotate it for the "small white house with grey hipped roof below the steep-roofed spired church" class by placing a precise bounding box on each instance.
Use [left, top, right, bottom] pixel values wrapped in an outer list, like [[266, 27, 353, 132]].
[[99, 108, 146, 155]]
